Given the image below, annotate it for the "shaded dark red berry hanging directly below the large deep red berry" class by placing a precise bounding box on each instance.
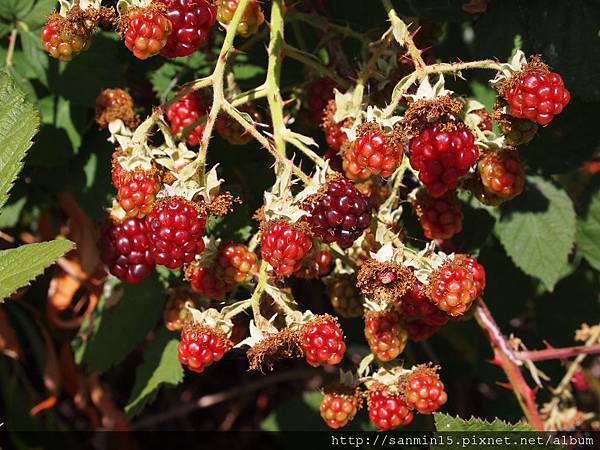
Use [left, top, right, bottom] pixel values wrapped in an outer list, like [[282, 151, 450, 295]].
[[415, 190, 463, 239]]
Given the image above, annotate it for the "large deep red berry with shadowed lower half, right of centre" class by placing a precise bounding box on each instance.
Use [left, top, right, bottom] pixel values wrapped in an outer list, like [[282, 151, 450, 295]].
[[410, 123, 479, 197]]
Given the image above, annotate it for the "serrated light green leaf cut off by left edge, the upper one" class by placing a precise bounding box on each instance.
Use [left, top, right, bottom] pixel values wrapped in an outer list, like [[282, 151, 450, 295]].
[[0, 72, 40, 208]]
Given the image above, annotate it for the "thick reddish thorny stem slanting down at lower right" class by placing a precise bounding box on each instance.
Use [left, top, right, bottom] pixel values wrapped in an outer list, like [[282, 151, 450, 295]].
[[475, 300, 544, 431]]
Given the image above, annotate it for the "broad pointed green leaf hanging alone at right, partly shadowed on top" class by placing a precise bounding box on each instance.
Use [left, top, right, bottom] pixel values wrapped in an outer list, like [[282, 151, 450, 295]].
[[492, 177, 575, 291]]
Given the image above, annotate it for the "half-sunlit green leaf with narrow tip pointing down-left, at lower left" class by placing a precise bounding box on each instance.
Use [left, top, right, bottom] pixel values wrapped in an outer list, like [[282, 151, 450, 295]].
[[125, 327, 183, 417]]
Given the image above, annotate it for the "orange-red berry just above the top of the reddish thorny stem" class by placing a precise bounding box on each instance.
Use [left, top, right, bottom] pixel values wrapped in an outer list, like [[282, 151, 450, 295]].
[[428, 264, 479, 316]]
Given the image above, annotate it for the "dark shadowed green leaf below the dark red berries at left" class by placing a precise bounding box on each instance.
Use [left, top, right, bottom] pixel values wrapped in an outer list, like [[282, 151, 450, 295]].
[[76, 276, 166, 372]]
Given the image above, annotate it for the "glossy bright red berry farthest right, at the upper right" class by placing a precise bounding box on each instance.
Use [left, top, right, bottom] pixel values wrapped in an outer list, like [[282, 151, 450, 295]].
[[503, 72, 571, 125]]
